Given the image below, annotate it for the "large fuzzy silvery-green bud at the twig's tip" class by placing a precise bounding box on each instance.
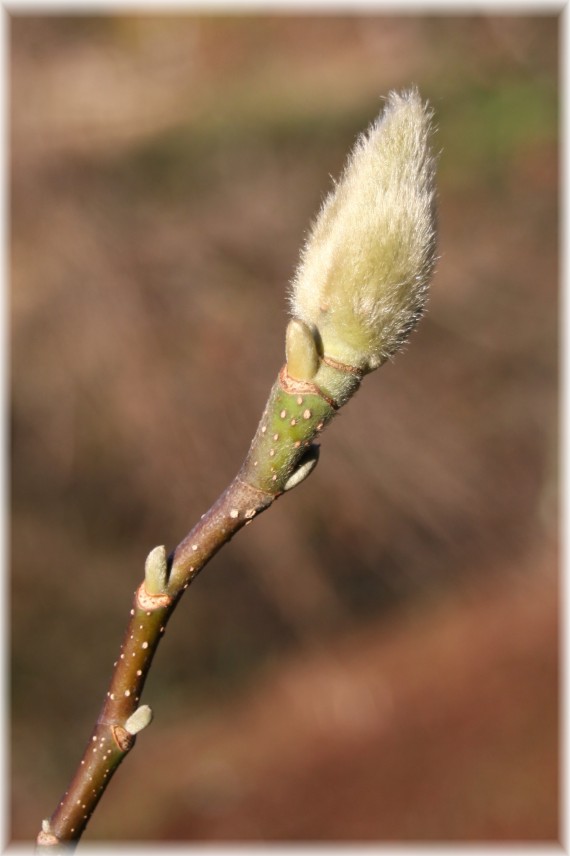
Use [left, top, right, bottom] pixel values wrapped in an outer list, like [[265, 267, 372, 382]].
[[290, 89, 436, 371]]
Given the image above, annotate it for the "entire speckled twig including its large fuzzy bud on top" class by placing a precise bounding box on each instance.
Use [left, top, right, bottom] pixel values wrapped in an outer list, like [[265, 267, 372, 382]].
[[37, 91, 435, 853]]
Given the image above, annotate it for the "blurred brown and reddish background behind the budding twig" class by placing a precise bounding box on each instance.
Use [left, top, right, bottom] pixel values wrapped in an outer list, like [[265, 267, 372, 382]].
[[10, 12, 559, 842]]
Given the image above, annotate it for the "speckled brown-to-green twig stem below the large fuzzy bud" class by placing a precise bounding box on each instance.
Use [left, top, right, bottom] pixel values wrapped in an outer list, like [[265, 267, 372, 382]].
[[37, 361, 360, 853]]
